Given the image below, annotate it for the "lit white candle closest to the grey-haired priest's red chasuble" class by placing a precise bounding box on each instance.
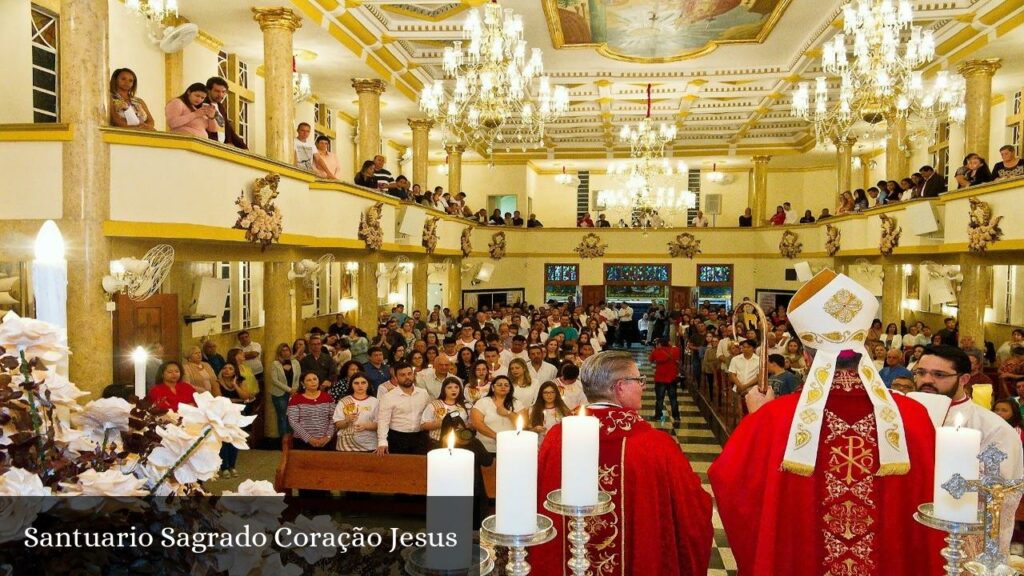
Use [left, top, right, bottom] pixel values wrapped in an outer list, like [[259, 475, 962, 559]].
[[562, 408, 600, 506]]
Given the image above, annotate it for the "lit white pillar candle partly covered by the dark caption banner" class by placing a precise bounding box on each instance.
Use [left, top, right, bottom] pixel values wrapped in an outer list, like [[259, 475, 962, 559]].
[[426, 431, 474, 570]]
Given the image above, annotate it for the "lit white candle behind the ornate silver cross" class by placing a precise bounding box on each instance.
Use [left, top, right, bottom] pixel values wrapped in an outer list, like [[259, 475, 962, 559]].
[[932, 414, 981, 522]]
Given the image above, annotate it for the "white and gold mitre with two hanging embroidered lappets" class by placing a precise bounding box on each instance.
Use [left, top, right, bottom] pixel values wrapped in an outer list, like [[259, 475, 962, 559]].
[[782, 270, 910, 476]]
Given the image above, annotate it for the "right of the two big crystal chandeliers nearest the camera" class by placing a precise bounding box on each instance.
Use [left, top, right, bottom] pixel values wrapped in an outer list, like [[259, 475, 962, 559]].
[[793, 0, 966, 145]]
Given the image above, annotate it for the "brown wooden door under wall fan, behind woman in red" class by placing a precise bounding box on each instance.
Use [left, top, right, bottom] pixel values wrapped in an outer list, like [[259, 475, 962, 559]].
[[114, 294, 181, 384]]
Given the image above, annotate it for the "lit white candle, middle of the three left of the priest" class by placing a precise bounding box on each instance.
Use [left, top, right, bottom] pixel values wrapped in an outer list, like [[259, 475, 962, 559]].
[[495, 416, 538, 535]]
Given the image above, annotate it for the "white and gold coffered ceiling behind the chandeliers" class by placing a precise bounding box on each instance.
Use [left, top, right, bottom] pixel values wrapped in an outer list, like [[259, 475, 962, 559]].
[[188, 0, 1024, 159]]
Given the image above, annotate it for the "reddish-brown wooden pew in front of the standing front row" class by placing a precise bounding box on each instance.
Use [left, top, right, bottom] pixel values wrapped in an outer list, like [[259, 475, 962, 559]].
[[273, 435, 495, 498]]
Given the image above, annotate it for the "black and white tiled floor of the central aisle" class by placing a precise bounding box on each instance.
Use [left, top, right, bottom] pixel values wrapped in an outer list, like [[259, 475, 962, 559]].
[[633, 348, 736, 576]]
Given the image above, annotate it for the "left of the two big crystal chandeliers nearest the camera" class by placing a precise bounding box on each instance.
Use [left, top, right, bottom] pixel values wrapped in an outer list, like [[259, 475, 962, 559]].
[[420, 1, 568, 156]]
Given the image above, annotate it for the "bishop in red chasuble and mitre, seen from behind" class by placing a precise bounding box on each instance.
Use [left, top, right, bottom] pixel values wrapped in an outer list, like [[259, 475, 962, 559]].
[[708, 270, 942, 576]]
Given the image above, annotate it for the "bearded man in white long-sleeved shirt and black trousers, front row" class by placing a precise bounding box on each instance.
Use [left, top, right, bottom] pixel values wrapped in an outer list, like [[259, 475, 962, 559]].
[[377, 362, 431, 456]]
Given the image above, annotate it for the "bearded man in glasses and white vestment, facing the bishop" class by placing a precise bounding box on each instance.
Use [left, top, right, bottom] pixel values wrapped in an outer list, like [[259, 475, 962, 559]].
[[913, 345, 1024, 553]]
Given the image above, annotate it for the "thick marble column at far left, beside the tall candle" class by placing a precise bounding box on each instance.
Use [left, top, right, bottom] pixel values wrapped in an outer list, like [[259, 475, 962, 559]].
[[58, 0, 112, 398]]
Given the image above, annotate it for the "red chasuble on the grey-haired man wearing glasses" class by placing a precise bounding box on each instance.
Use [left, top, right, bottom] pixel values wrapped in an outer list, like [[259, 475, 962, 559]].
[[528, 405, 714, 576]]
